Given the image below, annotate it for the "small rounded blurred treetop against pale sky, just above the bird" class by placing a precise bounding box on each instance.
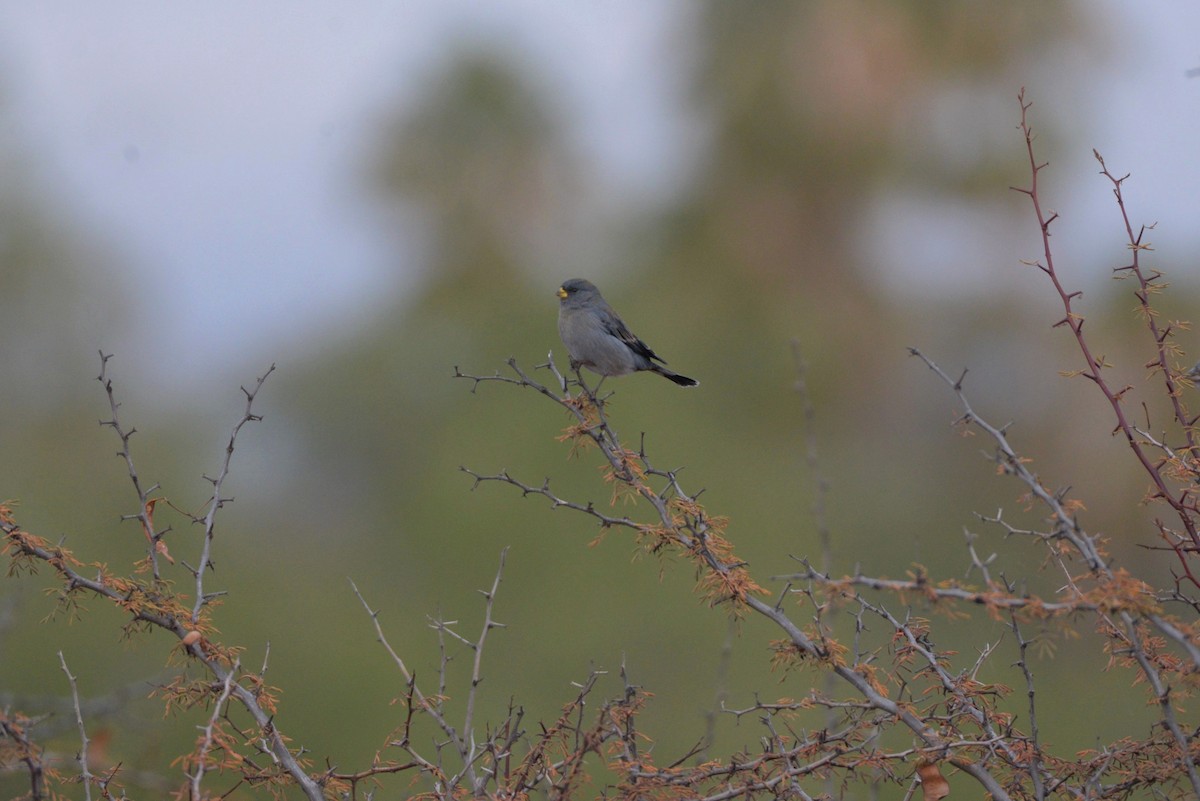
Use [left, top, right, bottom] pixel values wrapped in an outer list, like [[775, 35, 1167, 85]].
[[372, 52, 578, 281]]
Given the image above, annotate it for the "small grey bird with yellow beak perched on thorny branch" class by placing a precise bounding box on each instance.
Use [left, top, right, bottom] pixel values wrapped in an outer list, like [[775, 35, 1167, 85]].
[[558, 278, 700, 386]]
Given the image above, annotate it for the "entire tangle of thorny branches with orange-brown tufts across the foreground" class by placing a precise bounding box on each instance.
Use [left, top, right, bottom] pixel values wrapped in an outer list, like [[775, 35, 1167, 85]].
[[9, 92, 1200, 801]]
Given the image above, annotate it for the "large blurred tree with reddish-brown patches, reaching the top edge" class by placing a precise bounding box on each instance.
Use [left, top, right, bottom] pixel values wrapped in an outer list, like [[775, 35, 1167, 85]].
[[654, 0, 1086, 352]]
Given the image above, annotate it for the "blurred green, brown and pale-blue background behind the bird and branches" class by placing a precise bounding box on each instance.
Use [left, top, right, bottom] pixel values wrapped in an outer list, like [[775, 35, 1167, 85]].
[[0, 0, 1200, 793]]
